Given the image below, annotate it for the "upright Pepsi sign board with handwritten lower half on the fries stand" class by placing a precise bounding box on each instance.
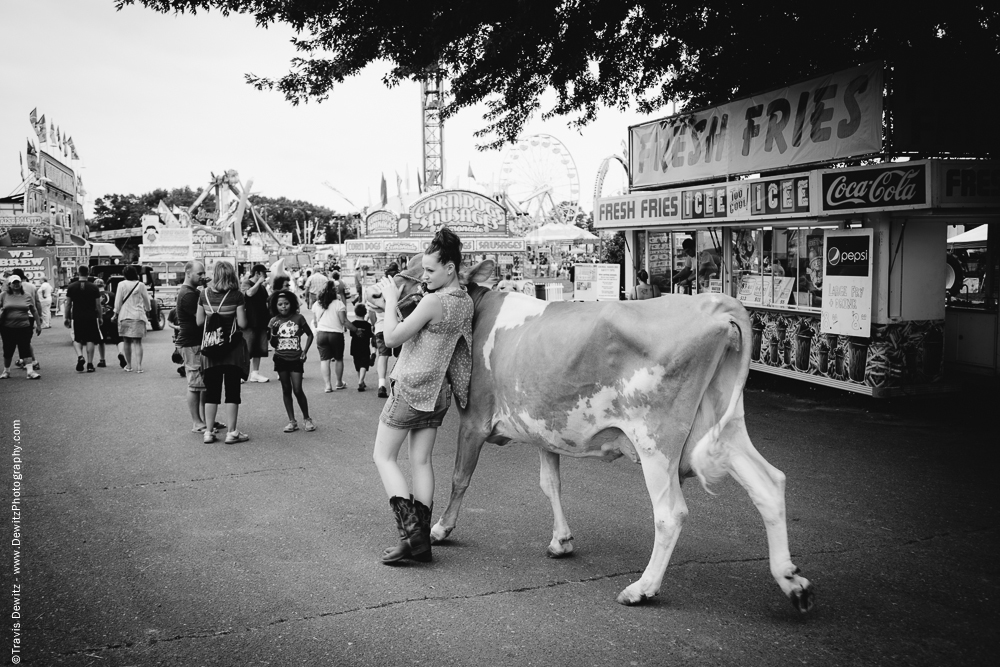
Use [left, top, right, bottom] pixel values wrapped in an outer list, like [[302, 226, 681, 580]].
[[820, 229, 873, 338]]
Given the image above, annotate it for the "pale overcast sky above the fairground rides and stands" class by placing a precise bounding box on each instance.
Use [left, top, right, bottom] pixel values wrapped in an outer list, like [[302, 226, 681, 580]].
[[0, 0, 648, 215]]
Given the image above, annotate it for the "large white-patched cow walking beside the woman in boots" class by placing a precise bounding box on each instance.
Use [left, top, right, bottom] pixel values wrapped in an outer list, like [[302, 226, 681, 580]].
[[397, 255, 814, 613]]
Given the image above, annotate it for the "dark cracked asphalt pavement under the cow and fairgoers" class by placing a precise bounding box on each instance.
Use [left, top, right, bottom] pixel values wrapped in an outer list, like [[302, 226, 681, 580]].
[[0, 318, 1000, 667]]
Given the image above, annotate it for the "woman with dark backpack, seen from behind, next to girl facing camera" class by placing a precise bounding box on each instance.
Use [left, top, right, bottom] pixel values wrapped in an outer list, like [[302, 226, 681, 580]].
[[195, 261, 250, 445]]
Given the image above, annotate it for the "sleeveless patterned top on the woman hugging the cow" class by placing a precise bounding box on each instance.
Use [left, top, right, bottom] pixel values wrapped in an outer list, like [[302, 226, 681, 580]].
[[390, 287, 473, 412]]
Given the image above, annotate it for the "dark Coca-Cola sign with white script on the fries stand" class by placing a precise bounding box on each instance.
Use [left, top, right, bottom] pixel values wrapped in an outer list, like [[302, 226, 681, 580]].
[[822, 162, 927, 212]]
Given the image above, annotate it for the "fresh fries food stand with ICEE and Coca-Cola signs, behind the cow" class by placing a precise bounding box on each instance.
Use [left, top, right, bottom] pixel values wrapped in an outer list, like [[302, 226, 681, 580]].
[[595, 62, 1000, 396]]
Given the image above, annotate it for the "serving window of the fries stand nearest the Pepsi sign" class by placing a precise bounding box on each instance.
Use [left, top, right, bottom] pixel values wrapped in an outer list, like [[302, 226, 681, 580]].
[[729, 226, 837, 311]]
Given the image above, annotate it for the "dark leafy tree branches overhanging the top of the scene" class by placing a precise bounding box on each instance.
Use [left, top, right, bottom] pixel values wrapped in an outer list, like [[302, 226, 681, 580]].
[[116, 0, 1000, 148]]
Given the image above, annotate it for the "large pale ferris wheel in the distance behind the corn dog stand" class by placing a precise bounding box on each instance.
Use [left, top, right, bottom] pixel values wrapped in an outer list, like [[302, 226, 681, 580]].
[[500, 134, 580, 224]]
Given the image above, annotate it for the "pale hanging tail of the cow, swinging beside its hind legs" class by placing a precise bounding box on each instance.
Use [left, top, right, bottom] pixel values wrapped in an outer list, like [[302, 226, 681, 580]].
[[690, 314, 752, 493]]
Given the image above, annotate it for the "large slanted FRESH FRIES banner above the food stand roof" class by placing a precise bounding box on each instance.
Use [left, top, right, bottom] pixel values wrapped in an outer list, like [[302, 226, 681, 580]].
[[629, 62, 883, 188]]
